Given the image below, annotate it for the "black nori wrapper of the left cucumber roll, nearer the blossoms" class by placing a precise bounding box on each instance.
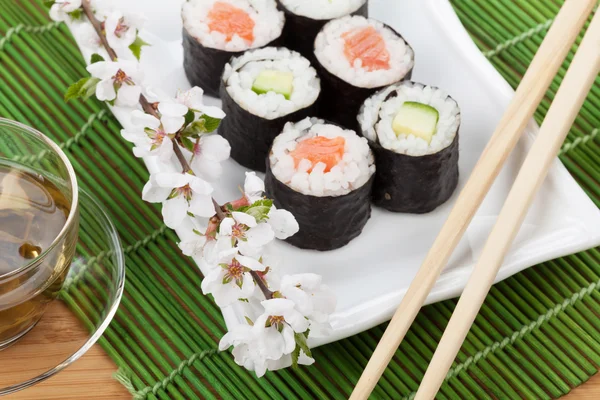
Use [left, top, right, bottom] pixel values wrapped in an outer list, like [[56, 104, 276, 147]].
[[217, 47, 320, 172]]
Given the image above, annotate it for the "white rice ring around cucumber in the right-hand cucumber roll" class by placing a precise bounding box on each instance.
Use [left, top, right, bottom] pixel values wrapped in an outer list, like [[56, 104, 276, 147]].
[[358, 81, 460, 156]]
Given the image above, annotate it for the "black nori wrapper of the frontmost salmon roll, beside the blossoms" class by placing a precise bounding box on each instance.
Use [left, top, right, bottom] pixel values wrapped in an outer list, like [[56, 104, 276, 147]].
[[265, 160, 374, 251]]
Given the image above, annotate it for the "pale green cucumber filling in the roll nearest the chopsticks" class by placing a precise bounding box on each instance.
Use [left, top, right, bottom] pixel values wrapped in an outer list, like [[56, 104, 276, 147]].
[[392, 101, 440, 143]]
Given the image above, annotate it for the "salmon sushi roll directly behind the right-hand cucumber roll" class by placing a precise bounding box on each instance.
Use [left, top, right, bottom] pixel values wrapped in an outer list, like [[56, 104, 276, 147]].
[[315, 16, 414, 129]]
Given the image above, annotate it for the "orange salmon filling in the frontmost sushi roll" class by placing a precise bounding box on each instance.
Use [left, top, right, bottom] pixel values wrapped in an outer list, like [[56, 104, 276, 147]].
[[290, 136, 346, 172]]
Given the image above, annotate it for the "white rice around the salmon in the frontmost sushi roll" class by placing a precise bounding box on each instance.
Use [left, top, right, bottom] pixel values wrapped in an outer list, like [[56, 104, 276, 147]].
[[269, 118, 375, 197]]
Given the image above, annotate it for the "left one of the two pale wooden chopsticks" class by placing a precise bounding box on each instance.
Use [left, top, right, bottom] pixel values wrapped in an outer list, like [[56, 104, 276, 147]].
[[350, 0, 596, 400]]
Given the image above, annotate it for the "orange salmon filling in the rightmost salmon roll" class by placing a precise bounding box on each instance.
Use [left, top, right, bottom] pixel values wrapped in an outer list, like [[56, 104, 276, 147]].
[[342, 26, 390, 71]]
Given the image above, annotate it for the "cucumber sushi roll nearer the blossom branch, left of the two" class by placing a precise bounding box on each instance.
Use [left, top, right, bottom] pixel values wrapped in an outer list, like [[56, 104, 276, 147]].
[[218, 47, 321, 172]]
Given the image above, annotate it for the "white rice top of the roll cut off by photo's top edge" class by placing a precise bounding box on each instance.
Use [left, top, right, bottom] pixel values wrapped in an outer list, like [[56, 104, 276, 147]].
[[280, 0, 367, 20]]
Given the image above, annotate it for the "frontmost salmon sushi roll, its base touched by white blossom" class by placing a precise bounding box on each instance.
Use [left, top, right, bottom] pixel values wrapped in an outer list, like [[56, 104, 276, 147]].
[[265, 118, 375, 251]]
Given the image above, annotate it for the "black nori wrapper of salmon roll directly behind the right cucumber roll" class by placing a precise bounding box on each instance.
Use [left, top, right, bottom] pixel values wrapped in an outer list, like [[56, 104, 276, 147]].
[[314, 24, 414, 132]]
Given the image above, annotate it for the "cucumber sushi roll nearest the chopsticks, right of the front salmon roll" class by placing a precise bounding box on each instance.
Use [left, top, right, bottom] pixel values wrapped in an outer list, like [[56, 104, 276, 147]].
[[358, 81, 460, 214]]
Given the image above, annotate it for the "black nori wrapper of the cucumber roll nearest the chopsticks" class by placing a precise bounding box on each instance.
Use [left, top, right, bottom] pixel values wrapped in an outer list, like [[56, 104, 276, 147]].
[[359, 85, 460, 214]]
